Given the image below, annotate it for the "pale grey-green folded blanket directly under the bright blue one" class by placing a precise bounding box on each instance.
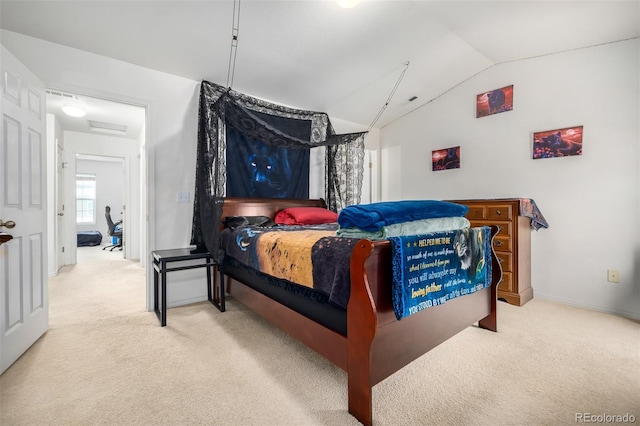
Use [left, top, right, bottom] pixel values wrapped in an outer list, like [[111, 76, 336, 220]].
[[337, 217, 470, 241]]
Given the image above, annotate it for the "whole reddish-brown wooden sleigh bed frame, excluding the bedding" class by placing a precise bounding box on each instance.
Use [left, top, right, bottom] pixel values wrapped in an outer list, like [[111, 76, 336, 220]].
[[216, 198, 501, 425]]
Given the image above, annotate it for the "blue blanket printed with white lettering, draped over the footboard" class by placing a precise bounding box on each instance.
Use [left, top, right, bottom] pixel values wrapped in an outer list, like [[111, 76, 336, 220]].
[[389, 227, 492, 320]]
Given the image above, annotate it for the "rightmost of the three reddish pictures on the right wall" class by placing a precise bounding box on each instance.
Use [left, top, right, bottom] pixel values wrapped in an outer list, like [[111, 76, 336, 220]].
[[533, 126, 582, 160]]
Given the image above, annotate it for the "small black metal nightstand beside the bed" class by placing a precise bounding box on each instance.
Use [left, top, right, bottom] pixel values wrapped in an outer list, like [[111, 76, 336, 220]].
[[151, 248, 225, 327]]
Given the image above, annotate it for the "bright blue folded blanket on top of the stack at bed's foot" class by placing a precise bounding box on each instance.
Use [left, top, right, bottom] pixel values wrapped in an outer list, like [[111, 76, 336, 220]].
[[338, 200, 469, 232]]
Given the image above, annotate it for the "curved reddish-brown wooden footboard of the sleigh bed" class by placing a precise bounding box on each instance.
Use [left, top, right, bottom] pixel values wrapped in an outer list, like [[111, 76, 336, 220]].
[[347, 235, 501, 425]]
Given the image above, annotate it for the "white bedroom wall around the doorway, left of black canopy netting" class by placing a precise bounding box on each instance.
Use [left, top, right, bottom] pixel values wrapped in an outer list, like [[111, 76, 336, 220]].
[[1, 30, 206, 307]]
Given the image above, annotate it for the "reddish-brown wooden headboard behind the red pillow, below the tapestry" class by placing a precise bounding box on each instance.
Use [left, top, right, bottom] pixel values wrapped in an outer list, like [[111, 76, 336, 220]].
[[222, 197, 327, 220]]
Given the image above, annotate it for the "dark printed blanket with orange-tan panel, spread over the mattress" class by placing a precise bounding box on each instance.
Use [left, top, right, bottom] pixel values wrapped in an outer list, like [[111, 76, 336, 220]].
[[221, 223, 358, 309]]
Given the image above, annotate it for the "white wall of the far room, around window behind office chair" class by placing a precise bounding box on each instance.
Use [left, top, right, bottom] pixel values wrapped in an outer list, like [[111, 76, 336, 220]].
[[76, 158, 124, 238]]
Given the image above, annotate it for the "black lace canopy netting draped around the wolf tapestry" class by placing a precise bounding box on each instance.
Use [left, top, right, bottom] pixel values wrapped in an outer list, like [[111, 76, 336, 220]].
[[191, 81, 366, 262]]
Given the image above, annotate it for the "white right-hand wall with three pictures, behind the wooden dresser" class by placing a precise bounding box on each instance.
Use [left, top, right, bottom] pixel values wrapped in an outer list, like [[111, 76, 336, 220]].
[[381, 39, 640, 317]]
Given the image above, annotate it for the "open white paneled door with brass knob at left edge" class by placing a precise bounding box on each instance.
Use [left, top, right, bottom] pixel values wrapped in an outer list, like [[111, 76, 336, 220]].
[[0, 46, 49, 373]]
